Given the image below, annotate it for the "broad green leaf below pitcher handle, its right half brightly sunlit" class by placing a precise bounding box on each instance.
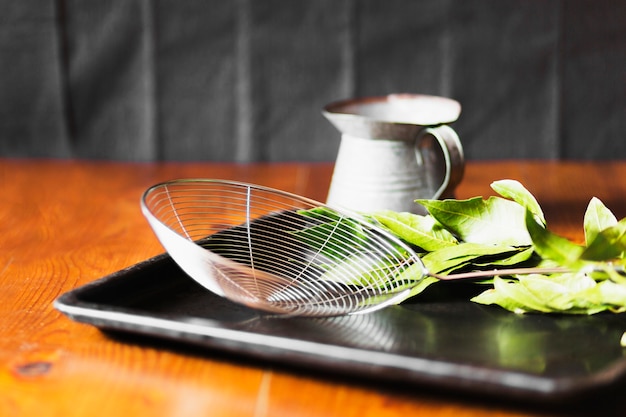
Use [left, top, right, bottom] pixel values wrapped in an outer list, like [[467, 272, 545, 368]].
[[416, 197, 531, 246]]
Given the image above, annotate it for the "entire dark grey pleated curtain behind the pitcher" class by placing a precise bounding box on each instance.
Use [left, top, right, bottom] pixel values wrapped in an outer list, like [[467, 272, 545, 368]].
[[0, 0, 626, 162]]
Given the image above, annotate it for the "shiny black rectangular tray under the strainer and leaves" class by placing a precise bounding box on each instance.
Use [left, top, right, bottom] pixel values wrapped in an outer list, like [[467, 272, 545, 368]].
[[55, 255, 626, 400]]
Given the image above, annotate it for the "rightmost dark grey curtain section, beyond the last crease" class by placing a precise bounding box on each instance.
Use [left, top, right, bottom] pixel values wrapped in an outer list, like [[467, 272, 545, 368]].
[[560, 0, 626, 159]]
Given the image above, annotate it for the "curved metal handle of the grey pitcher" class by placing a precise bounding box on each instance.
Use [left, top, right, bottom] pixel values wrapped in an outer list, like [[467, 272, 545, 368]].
[[416, 125, 465, 199]]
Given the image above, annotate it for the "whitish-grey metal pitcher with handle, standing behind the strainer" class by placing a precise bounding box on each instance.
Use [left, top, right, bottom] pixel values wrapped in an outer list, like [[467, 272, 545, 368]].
[[322, 94, 465, 213]]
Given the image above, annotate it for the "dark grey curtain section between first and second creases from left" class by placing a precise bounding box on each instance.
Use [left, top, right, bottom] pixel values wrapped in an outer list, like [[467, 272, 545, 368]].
[[60, 0, 159, 160]]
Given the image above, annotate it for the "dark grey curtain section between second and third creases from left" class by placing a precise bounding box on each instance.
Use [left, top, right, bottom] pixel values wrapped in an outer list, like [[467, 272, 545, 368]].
[[153, 0, 236, 161]]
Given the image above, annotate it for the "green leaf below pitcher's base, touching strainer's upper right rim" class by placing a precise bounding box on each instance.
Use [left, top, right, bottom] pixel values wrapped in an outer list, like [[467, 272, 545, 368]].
[[371, 210, 457, 252]]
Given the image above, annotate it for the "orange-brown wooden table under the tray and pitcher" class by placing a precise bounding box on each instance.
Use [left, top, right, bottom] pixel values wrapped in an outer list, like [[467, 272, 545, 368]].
[[0, 160, 626, 417]]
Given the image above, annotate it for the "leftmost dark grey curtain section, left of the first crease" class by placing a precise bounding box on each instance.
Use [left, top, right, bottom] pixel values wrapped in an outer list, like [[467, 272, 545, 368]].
[[0, 0, 71, 157]]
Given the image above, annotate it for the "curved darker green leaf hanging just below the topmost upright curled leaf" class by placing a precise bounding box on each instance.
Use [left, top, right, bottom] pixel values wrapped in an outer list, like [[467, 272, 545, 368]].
[[526, 211, 584, 267]]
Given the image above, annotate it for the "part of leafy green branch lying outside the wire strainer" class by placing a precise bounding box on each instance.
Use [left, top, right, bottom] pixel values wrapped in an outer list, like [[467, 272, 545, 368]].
[[369, 180, 626, 314]]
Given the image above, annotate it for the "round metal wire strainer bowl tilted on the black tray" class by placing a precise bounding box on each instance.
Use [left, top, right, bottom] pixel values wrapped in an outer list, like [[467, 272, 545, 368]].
[[141, 179, 422, 316]]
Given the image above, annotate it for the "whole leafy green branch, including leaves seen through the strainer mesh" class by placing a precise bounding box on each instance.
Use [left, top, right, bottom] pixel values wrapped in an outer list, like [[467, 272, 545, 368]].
[[294, 180, 626, 320]]
